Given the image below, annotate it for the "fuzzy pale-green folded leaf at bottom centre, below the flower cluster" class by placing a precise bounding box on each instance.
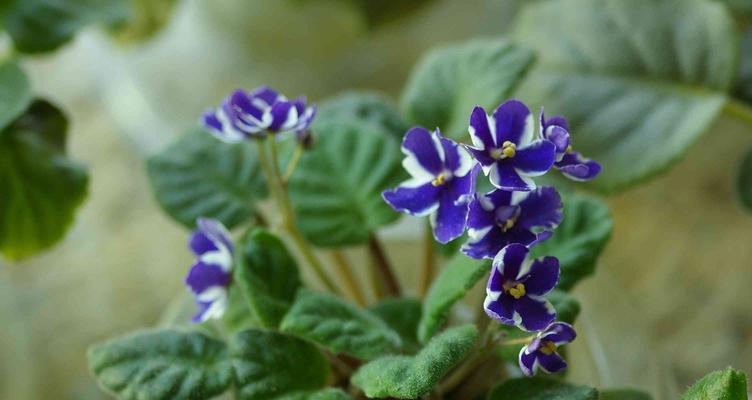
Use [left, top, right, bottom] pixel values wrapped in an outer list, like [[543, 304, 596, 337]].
[[350, 325, 478, 399]]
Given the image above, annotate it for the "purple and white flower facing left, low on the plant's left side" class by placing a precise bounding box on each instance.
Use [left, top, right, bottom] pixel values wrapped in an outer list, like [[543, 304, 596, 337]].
[[185, 218, 234, 322]]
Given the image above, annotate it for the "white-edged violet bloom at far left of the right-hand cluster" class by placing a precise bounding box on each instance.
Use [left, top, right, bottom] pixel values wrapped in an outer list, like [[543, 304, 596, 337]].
[[381, 127, 478, 243]]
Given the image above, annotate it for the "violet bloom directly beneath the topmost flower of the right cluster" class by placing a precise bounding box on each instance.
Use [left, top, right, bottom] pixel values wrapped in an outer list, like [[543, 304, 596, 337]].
[[462, 187, 562, 258]]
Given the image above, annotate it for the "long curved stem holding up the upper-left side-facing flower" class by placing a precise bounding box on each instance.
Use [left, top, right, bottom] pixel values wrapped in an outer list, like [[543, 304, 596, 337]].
[[258, 136, 341, 294]]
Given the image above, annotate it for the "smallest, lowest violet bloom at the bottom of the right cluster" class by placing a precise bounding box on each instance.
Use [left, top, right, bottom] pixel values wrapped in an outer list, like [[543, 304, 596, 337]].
[[519, 322, 577, 376]]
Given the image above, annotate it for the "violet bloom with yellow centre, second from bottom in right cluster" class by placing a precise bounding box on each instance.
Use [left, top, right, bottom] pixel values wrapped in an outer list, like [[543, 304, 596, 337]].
[[483, 243, 559, 331]]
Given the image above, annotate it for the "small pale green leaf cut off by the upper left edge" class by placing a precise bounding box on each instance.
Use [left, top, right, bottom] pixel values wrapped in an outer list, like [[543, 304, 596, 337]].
[[0, 61, 31, 129]]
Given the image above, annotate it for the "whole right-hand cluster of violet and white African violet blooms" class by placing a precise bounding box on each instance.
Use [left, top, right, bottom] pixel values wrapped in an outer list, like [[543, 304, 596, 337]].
[[382, 100, 601, 375]]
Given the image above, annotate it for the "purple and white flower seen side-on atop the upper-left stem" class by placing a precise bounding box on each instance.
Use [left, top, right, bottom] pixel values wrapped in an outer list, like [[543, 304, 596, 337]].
[[203, 86, 316, 143]]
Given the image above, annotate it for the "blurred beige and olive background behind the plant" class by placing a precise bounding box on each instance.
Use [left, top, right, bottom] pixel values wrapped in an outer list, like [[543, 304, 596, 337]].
[[0, 0, 752, 400]]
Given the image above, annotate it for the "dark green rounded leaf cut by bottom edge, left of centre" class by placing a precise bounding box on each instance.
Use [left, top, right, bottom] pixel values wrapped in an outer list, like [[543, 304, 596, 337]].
[[230, 329, 329, 400]]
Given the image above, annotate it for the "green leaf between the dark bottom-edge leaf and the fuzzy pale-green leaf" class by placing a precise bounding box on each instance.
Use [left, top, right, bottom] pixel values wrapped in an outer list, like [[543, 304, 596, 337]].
[[280, 289, 401, 360]]
